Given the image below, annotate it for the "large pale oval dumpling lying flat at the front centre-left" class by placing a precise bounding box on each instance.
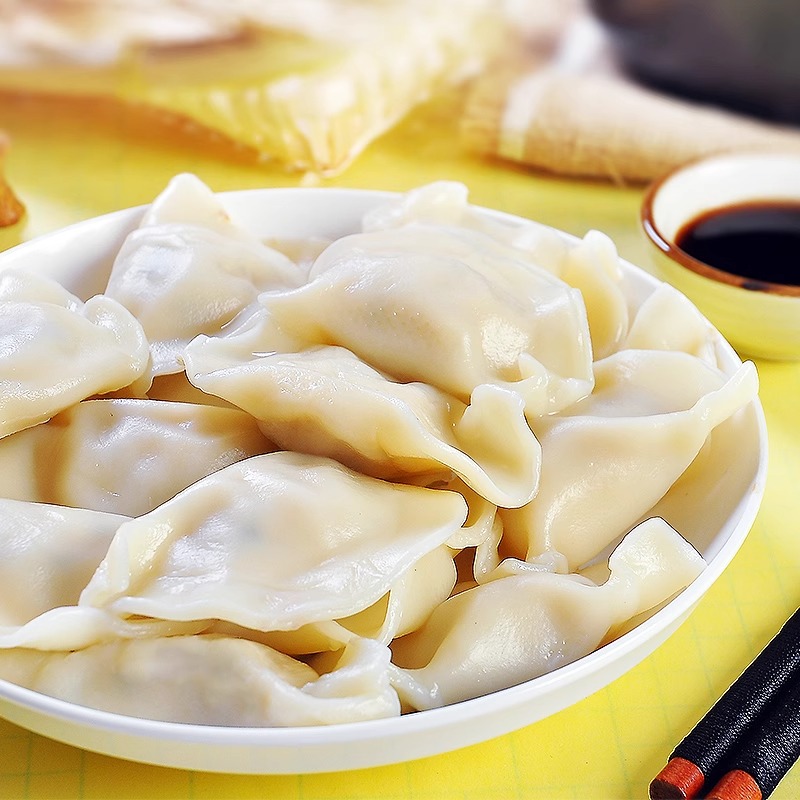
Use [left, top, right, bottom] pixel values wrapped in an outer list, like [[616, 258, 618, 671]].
[[80, 452, 467, 631]]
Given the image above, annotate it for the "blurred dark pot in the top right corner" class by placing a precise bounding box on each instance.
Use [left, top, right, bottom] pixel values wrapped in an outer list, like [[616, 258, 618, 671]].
[[589, 0, 800, 124]]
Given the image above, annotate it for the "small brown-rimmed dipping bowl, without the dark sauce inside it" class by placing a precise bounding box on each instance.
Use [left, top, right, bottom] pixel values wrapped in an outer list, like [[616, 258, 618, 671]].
[[641, 152, 800, 359]]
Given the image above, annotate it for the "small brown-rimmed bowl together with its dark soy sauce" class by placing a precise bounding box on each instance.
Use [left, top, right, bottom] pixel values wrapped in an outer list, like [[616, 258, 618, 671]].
[[641, 152, 800, 359]]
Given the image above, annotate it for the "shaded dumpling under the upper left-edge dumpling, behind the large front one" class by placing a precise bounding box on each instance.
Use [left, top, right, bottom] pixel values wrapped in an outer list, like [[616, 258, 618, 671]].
[[0, 399, 275, 517]]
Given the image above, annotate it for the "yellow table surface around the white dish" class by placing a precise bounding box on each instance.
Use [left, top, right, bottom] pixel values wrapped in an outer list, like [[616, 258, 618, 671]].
[[0, 89, 800, 800]]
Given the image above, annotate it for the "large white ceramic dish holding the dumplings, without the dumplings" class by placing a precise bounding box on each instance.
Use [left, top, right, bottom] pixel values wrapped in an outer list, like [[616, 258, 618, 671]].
[[0, 189, 767, 774]]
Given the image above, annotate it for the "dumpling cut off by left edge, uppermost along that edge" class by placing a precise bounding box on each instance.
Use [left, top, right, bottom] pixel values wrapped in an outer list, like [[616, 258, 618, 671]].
[[0, 270, 149, 437]]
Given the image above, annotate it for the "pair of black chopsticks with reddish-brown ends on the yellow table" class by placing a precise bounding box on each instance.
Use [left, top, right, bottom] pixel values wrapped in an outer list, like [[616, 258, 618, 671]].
[[650, 609, 800, 800]]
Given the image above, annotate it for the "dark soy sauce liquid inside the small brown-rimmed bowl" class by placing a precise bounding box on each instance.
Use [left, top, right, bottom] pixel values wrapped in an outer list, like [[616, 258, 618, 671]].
[[675, 201, 800, 286]]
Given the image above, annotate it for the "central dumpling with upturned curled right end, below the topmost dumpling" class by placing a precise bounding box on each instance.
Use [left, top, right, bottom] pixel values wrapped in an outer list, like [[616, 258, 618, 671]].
[[183, 336, 540, 506]]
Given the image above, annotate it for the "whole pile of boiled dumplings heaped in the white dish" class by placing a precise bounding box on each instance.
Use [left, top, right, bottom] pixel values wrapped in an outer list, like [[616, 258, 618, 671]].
[[0, 175, 757, 726]]
